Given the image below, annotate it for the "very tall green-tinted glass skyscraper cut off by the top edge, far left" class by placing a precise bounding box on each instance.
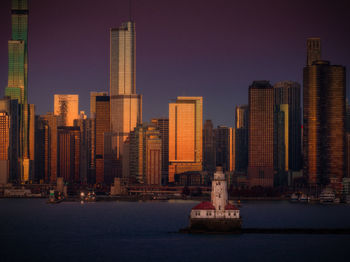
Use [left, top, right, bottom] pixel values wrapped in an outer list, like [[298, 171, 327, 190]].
[[5, 0, 30, 182]]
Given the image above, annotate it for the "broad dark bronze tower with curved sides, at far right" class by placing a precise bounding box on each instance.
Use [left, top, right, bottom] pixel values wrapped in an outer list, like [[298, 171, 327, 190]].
[[303, 60, 346, 185]]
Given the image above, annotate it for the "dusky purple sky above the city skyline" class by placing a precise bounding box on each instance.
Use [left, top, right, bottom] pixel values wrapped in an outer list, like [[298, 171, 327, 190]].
[[0, 0, 350, 126]]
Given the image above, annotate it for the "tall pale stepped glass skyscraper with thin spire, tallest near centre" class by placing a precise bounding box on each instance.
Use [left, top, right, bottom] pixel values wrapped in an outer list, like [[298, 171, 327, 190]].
[[110, 21, 142, 177]]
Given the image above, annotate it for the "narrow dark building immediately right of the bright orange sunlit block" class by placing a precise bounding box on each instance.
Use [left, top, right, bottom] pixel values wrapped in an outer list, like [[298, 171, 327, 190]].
[[203, 120, 216, 173]]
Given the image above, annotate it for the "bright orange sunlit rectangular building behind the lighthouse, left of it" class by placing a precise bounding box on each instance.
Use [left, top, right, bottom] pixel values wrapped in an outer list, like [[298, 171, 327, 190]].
[[169, 96, 203, 182]]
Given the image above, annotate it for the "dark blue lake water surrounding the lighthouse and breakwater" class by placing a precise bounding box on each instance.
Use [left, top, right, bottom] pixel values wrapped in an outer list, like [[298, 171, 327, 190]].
[[0, 199, 350, 262]]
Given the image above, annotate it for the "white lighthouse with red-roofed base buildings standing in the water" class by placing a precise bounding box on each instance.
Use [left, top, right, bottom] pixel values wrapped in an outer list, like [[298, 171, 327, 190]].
[[189, 167, 242, 232]]
